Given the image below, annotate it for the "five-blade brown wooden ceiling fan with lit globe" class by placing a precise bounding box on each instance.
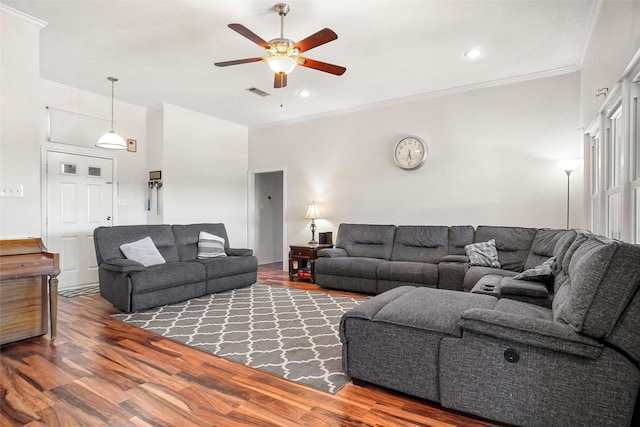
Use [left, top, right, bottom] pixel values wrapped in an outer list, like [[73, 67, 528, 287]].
[[215, 3, 347, 89]]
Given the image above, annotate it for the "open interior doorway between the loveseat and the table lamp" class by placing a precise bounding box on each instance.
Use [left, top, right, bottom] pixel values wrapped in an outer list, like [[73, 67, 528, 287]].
[[249, 170, 285, 264]]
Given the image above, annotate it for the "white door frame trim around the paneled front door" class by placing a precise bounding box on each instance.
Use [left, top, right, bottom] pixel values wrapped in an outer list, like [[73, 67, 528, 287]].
[[40, 142, 118, 246]]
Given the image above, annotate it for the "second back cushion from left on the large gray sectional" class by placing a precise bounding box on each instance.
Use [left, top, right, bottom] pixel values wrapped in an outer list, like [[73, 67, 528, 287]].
[[391, 225, 449, 264]]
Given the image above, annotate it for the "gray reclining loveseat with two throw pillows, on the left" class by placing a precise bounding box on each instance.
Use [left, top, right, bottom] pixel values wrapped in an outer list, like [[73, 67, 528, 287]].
[[93, 224, 258, 313]]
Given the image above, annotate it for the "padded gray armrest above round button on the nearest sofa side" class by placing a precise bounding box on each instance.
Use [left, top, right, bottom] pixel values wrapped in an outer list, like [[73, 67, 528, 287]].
[[461, 308, 604, 359]]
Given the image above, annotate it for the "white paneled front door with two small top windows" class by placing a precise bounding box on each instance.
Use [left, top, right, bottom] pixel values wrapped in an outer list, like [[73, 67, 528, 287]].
[[47, 151, 113, 288]]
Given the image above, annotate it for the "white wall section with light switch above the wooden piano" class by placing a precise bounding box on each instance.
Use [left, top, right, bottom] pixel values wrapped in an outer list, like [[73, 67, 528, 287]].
[[0, 5, 44, 239]]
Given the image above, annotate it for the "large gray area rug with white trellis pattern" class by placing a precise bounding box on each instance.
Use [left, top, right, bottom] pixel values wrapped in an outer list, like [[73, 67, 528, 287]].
[[113, 284, 363, 394]]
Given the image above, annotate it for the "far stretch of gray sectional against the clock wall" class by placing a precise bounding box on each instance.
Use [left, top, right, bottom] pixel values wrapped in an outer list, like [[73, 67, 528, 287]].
[[314, 224, 576, 306]]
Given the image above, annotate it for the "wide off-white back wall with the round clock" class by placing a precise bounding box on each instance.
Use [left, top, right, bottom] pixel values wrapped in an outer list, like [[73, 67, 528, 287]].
[[249, 73, 586, 244]]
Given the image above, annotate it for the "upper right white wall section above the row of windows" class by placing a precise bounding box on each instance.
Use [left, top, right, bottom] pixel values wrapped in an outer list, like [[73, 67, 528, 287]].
[[580, 1, 640, 127]]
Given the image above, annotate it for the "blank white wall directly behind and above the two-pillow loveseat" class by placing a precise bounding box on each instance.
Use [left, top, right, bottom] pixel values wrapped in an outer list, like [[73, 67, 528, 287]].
[[159, 104, 248, 247]]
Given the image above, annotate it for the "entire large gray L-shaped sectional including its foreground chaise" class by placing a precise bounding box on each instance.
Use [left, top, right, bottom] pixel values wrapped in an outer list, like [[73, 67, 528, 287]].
[[315, 224, 640, 426]]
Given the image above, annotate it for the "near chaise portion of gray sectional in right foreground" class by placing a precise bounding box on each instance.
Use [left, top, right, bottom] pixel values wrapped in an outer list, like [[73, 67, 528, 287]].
[[340, 232, 640, 427]]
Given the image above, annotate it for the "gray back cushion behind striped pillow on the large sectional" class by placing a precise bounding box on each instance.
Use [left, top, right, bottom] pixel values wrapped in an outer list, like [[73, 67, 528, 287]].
[[475, 225, 538, 272]]
